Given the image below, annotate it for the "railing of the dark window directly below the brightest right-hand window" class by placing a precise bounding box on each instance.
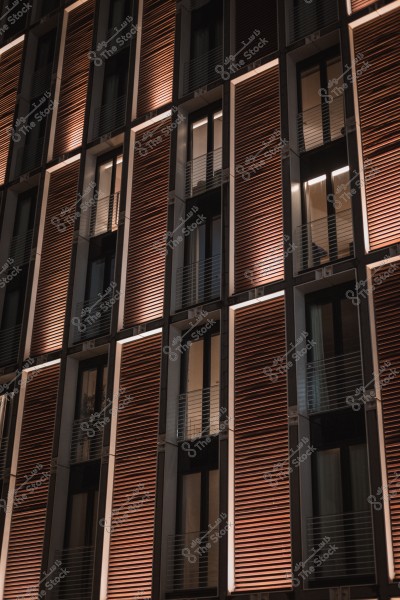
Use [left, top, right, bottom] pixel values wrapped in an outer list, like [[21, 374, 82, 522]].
[[307, 352, 363, 414]]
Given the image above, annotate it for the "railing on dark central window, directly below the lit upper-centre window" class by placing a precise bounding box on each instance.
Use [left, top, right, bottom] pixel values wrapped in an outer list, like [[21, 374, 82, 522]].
[[176, 255, 221, 310]]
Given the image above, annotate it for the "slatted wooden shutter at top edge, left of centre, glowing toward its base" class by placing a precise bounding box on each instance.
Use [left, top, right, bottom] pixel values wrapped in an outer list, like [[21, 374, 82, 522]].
[[138, 0, 176, 116]]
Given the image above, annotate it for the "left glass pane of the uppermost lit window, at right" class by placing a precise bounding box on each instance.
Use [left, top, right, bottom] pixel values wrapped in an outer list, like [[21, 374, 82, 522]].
[[301, 68, 324, 150]]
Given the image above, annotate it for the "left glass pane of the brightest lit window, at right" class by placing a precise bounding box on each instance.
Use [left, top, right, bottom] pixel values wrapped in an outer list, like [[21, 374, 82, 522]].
[[301, 175, 329, 267]]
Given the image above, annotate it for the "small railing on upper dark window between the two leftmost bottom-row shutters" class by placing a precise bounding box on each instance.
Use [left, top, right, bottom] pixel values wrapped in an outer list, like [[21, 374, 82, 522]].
[[70, 417, 104, 464]]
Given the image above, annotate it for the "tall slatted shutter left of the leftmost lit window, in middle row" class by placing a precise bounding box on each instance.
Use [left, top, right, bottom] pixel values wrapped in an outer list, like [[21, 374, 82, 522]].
[[31, 160, 79, 356]]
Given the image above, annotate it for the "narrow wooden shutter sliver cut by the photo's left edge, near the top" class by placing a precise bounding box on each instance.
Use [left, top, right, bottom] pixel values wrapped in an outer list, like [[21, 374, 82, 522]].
[[0, 41, 24, 185]]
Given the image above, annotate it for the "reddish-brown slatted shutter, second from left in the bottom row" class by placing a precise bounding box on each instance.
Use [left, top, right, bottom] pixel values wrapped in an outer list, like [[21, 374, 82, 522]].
[[107, 334, 161, 600]]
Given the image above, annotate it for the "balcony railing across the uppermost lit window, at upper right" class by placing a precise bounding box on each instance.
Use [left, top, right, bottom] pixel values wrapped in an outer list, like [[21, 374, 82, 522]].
[[297, 95, 345, 153]]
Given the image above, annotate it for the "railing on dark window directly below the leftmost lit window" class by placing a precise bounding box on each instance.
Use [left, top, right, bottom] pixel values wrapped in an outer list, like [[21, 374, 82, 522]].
[[72, 294, 115, 343]]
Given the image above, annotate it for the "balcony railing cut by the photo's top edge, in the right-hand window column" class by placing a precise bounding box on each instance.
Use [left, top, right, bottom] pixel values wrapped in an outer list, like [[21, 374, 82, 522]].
[[289, 0, 338, 44]]
